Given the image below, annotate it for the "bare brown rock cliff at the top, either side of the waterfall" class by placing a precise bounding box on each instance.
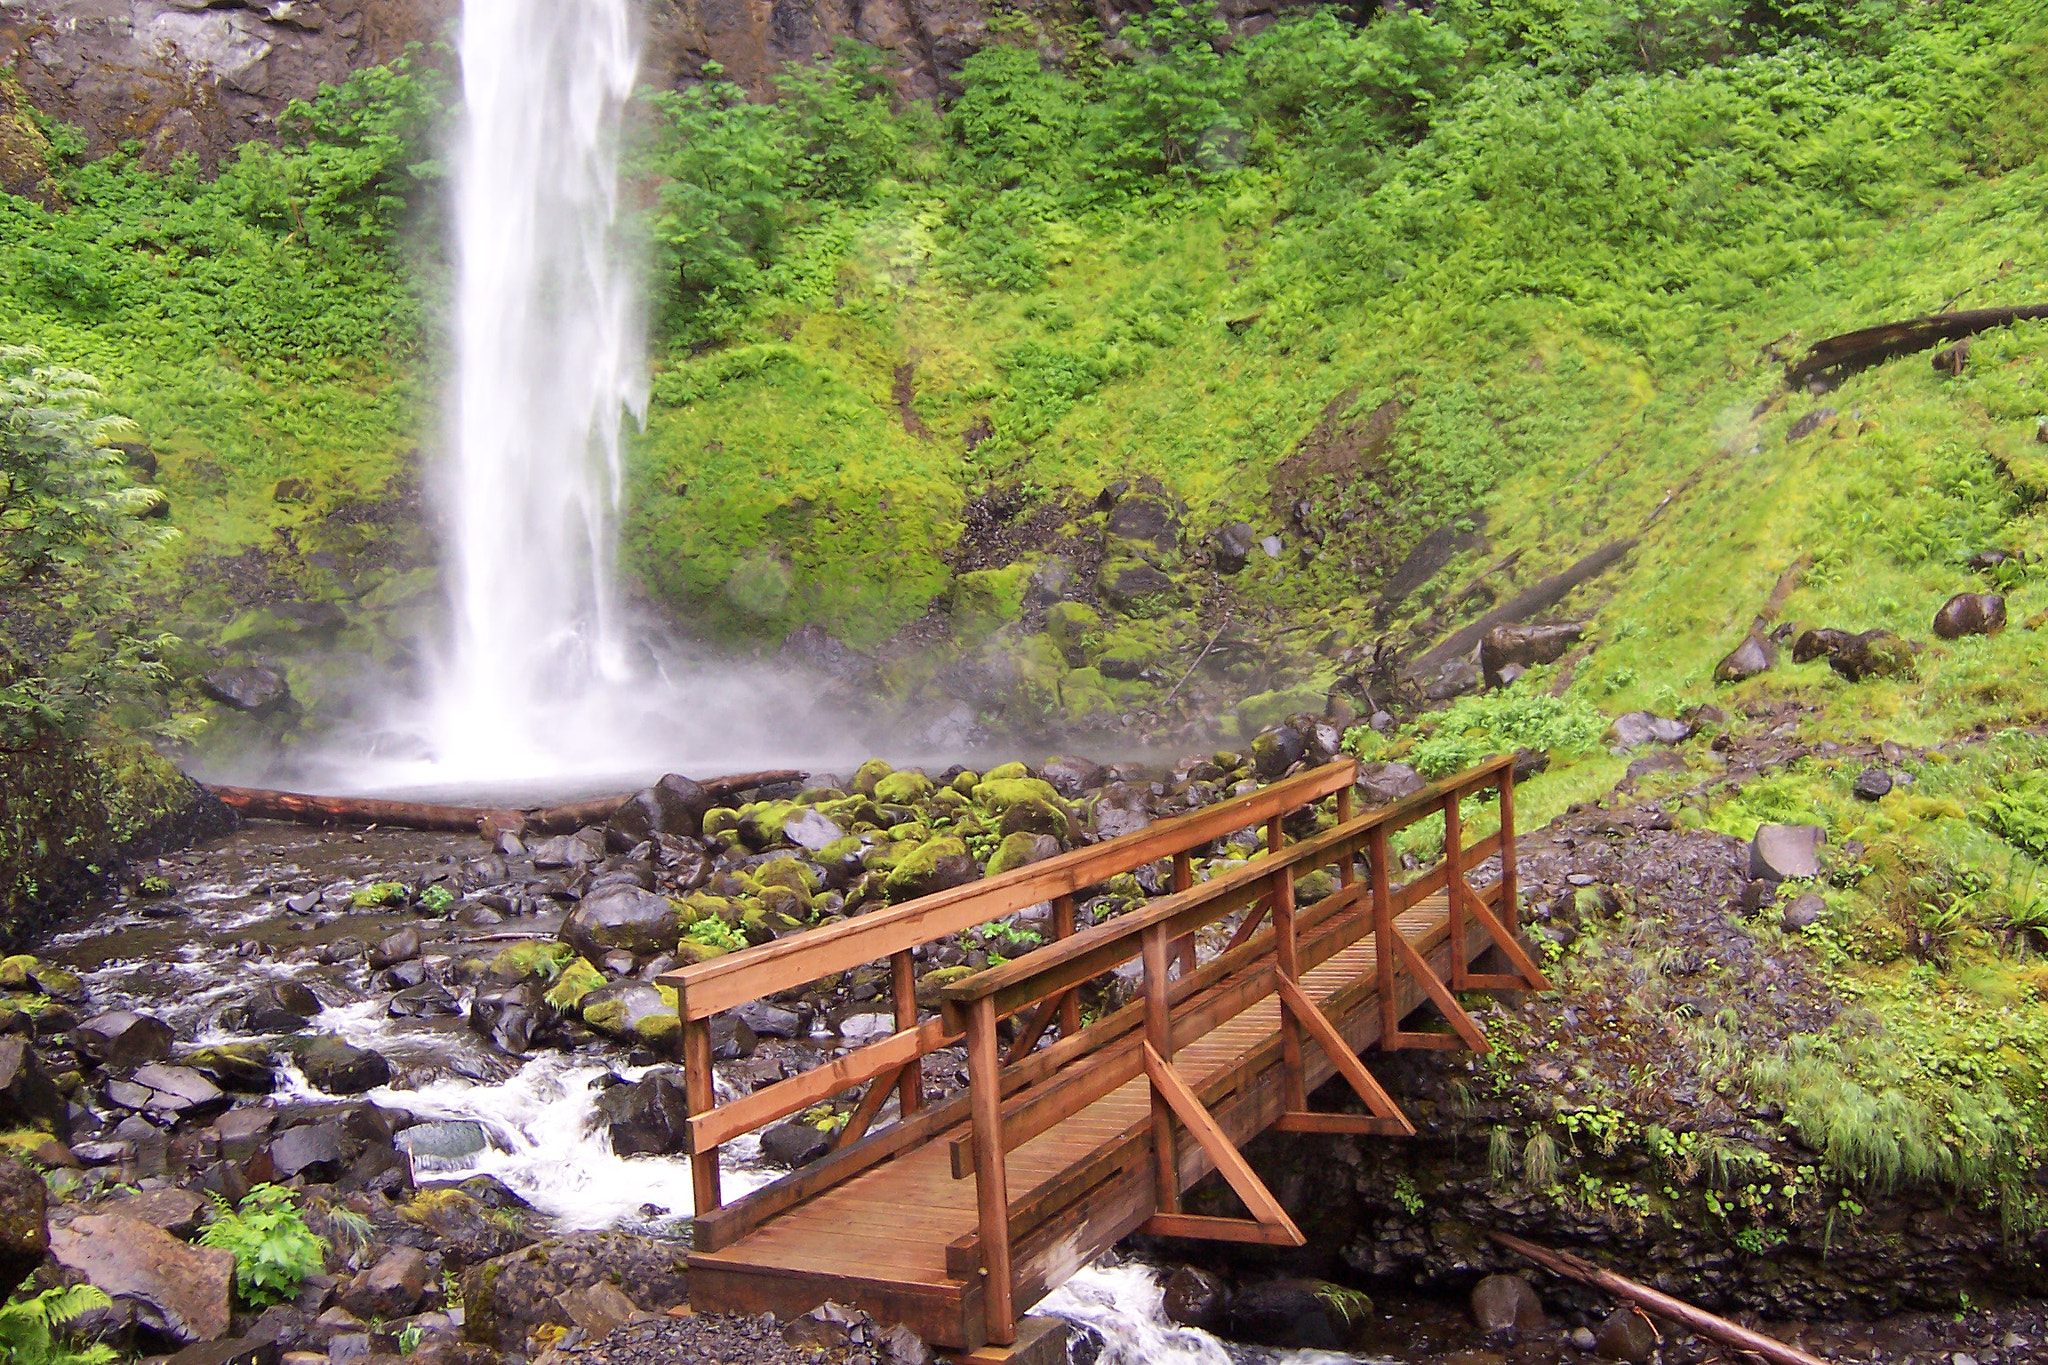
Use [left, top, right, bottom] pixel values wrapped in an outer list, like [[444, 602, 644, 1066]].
[[0, 0, 1310, 174]]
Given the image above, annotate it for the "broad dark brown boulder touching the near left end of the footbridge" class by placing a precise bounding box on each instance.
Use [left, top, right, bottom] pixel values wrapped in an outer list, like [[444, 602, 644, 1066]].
[[463, 1232, 690, 1355]]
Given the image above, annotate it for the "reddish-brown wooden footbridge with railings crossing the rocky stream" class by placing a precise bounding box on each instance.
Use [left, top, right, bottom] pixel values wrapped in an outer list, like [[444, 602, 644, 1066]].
[[664, 757, 1548, 1351]]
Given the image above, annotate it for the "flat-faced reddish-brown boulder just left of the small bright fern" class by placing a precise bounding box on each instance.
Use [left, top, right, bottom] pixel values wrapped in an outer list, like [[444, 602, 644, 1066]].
[[49, 1214, 236, 1342]]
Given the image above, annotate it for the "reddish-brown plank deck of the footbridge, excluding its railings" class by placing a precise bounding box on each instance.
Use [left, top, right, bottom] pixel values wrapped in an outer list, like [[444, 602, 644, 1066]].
[[690, 892, 1474, 1347]]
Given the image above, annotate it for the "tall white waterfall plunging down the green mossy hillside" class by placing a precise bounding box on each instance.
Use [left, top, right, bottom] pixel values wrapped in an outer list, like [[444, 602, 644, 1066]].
[[426, 0, 645, 778]]
